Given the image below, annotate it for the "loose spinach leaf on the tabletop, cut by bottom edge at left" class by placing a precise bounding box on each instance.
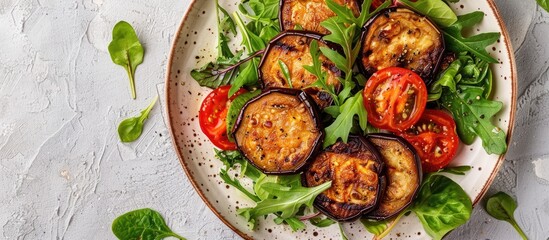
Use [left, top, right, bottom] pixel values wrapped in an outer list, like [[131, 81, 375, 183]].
[[112, 208, 185, 240]]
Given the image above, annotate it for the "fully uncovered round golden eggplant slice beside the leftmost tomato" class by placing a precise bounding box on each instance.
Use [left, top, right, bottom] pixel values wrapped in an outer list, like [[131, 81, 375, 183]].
[[233, 88, 324, 174]]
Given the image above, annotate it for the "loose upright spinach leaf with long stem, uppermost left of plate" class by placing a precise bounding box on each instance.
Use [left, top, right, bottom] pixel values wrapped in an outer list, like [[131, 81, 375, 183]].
[[109, 21, 144, 99]]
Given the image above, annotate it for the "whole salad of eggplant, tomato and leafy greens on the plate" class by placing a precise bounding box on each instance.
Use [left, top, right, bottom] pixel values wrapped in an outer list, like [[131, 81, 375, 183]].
[[191, 0, 507, 239]]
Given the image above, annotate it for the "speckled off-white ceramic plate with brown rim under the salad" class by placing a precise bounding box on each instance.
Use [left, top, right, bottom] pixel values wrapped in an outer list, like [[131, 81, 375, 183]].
[[166, 0, 517, 239]]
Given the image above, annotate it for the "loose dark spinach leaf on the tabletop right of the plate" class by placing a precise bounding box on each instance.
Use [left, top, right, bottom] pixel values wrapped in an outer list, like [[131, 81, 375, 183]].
[[486, 192, 528, 240]]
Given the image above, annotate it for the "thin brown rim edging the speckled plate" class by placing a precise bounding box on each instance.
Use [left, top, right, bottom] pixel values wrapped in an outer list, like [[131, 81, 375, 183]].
[[164, 0, 518, 239]]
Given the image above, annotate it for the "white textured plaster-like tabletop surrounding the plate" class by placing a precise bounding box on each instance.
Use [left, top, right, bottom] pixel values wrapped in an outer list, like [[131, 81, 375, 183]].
[[0, 0, 549, 239]]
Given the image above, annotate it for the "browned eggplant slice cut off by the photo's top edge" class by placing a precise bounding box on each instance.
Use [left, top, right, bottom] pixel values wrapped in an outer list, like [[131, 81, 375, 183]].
[[278, 0, 360, 34]]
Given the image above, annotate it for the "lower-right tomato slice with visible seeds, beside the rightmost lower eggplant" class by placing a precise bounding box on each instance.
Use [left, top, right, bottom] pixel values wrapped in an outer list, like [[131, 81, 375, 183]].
[[399, 109, 459, 172]]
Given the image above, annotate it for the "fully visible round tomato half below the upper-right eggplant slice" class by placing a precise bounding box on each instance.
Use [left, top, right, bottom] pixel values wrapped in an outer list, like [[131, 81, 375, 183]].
[[363, 67, 427, 132]]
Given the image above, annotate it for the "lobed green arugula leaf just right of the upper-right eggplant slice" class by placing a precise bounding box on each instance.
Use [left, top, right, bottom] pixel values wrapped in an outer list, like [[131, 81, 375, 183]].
[[442, 11, 501, 63]]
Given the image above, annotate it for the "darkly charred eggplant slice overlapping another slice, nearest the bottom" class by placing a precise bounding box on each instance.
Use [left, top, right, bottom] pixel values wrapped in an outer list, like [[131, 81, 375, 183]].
[[302, 136, 385, 221]]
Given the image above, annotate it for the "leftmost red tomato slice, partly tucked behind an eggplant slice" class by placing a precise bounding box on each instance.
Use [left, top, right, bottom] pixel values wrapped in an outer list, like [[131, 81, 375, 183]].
[[198, 85, 247, 150]]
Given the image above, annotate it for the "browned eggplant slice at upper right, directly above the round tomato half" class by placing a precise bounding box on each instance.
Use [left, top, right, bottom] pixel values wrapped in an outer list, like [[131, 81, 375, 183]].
[[359, 8, 444, 81]]
